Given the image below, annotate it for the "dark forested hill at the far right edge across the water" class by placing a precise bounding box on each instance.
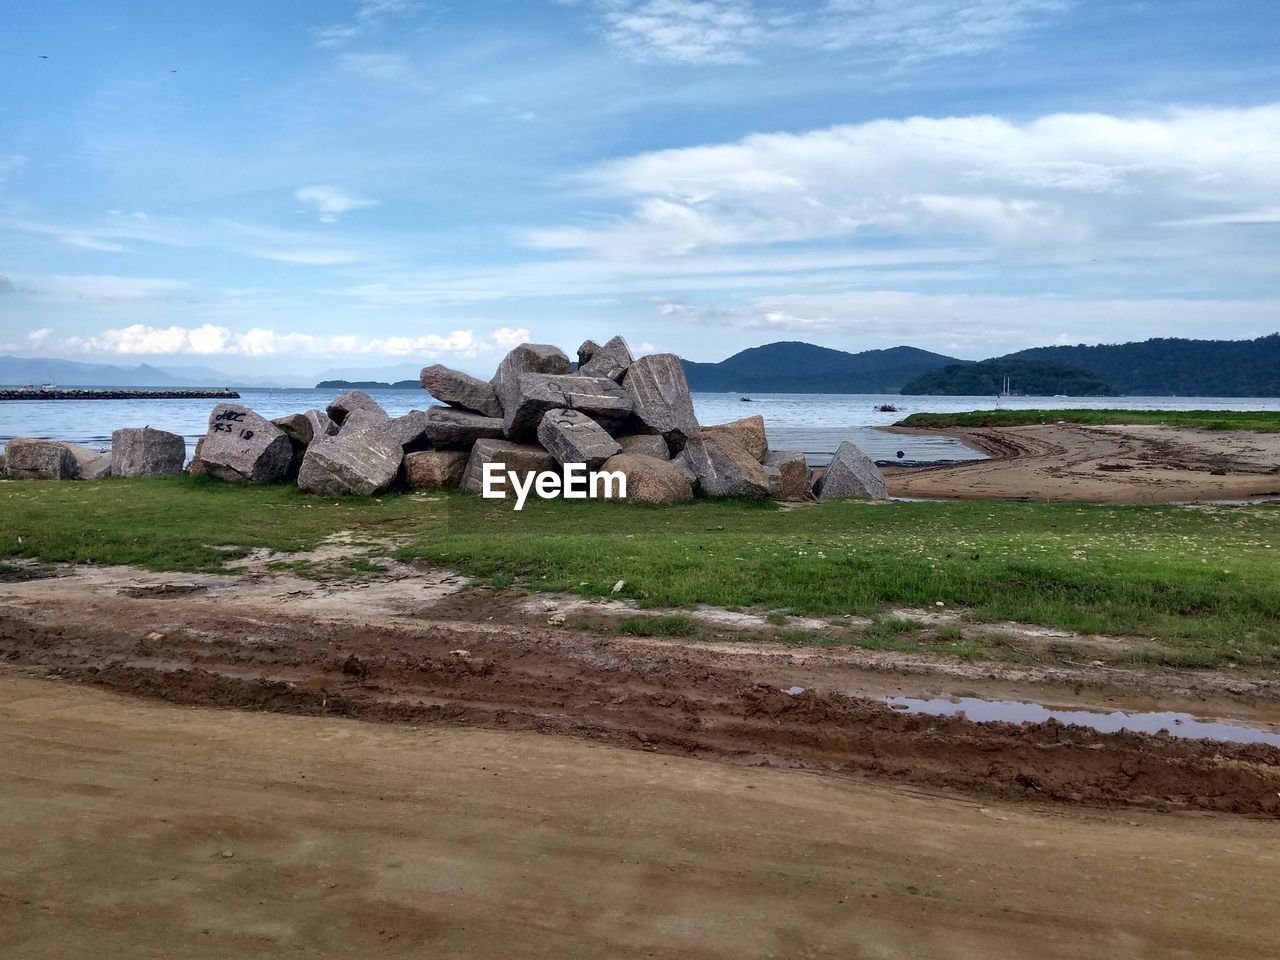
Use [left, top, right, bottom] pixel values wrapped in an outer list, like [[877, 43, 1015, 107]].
[[1001, 333, 1280, 397]]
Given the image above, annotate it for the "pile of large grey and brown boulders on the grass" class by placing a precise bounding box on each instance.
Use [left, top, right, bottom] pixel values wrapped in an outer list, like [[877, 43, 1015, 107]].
[[8, 337, 886, 503]]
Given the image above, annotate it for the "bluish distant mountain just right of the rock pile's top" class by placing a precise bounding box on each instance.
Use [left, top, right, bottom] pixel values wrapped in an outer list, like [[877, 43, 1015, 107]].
[[682, 340, 966, 393]]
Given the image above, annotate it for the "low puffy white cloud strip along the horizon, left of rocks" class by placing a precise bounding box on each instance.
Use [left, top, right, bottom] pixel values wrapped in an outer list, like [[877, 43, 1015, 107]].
[[38, 324, 531, 358]]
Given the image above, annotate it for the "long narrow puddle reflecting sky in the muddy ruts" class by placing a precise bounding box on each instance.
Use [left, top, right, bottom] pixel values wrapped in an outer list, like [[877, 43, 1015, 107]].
[[883, 696, 1280, 746]]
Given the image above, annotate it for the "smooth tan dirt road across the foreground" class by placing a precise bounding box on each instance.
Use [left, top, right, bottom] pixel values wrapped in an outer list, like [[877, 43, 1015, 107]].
[[0, 669, 1280, 960]]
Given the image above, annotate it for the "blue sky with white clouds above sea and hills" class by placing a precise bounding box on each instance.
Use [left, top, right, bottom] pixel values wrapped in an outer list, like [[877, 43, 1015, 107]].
[[0, 0, 1280, 375]]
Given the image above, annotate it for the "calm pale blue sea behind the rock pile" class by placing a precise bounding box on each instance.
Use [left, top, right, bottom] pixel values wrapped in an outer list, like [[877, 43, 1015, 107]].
[[0, 388, 1280, 463]]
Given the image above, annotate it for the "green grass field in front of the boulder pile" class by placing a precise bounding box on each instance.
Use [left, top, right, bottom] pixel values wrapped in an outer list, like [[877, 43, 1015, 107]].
[[0, 477, 1280, 664]]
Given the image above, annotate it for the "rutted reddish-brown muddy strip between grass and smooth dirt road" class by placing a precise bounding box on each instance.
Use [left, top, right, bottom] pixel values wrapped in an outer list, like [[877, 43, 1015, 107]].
[[0, 568, 1280, 817]]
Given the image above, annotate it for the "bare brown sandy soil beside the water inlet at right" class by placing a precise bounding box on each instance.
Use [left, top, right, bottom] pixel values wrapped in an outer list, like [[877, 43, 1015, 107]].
[[884, 424, 1280, 503]]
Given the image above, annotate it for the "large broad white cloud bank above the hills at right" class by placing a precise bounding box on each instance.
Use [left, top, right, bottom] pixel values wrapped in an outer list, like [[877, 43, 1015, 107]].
[[527, 104, 1280, 256]]
